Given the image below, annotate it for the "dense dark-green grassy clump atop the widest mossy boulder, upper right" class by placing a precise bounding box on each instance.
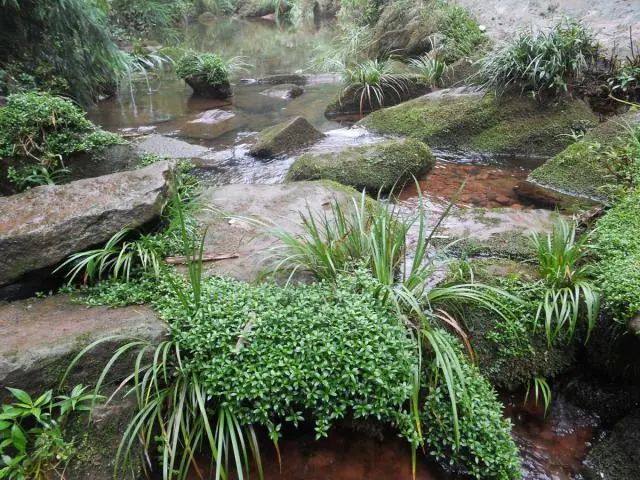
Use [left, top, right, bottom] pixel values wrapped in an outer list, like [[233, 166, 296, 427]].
[[477, 20, 598, 95]]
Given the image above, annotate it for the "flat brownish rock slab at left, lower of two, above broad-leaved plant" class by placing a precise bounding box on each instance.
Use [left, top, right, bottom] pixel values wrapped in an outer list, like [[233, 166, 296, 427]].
[[0, 295, 166, 400]]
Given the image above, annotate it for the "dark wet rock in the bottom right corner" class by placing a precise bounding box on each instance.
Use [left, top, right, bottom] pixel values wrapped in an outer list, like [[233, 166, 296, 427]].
[[583, 409, 640, 480]]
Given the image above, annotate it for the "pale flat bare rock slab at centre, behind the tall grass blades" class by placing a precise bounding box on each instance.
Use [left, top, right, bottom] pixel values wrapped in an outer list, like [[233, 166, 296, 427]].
[[199, 182, 358, 281]]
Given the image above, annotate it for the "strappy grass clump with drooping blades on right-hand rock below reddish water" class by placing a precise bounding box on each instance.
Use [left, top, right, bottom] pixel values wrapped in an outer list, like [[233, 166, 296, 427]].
[[532, 219, 600, 345]]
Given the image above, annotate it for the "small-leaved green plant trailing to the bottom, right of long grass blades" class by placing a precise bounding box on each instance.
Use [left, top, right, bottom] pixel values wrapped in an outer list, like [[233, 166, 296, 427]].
[[423, 344, 522, 480]]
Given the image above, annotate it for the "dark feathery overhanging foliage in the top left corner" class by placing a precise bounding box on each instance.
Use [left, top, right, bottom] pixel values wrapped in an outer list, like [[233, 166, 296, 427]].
[[0, 0, 127, 103]]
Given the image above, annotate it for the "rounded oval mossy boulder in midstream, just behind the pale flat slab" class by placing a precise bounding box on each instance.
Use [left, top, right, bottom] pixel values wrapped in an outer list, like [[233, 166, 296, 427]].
[[287, 139, 435, 195]]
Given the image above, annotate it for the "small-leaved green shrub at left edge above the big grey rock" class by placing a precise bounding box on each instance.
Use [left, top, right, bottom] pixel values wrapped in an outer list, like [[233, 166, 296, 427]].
[[0, 92, 121, 188]]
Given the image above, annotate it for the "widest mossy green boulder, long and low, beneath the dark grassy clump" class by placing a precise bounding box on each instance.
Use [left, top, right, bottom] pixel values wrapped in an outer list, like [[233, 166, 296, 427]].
[[360, 88, 598, 157]]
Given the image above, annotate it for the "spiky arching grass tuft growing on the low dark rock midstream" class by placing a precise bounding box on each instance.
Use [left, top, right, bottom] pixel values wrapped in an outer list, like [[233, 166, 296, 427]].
[[342, 59, 406, 113]]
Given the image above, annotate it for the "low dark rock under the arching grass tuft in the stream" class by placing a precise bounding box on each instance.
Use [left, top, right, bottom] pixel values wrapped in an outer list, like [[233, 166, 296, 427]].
[[324, 75, 431, 118]]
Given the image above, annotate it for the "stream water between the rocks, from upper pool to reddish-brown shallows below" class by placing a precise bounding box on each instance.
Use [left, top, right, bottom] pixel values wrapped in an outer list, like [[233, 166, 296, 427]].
[[90, 18, 595, 480]]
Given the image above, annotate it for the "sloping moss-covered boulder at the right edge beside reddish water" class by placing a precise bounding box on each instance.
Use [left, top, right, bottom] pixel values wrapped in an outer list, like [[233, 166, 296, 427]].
[[528, 111, 640, 201]]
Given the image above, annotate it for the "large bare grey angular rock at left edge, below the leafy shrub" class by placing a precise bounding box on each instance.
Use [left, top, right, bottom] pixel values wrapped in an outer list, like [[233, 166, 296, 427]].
[[0, 161, 173, 298]]
